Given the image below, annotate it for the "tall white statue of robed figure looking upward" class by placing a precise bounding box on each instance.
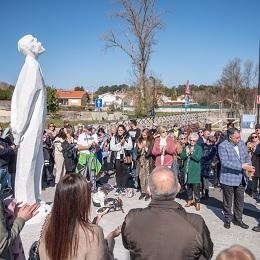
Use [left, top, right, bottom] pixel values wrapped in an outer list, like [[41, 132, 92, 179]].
[[11, 35, 46, 203]]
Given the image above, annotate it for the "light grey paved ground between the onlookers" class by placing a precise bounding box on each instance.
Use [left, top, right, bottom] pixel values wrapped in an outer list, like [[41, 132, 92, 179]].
[[21, 179, 260, 260]]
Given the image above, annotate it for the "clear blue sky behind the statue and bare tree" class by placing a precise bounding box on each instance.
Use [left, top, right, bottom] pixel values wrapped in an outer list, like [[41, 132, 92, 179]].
[[0, 0, 260, 90]]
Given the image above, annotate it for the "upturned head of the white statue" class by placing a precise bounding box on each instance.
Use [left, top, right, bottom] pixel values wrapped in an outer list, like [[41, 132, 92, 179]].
[[18, 34, 45, 59]]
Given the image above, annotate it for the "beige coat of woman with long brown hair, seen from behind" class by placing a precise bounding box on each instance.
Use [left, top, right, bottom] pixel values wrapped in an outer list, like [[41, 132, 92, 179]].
[[39, 224, 113, 260]]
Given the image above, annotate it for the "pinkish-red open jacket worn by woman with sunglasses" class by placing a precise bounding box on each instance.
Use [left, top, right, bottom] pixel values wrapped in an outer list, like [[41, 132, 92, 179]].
[[152, 136, 175, 167]]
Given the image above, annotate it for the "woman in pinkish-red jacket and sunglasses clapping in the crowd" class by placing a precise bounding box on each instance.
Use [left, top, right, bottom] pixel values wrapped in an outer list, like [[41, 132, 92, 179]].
[[152, 126, 175, 168]]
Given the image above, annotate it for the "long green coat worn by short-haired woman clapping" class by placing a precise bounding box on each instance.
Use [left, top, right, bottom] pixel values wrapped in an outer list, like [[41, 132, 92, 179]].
[[181, 144, 202, 184]]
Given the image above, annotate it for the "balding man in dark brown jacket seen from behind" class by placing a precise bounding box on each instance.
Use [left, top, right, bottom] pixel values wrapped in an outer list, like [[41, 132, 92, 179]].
[[122, 166, 213, 260]]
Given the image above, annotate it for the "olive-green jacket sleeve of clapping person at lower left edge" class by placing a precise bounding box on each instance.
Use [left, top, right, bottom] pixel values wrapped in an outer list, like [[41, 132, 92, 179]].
[[0, 200, 25, 260]]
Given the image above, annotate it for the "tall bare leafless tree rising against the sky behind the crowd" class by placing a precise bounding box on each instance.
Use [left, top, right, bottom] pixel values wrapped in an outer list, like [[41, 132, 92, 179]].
[[103, 0, 162, 103]]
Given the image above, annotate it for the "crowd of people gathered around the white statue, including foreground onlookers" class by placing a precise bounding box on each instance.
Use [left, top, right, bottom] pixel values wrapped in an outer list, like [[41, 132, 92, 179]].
[[0, 120, 260, 260]]
